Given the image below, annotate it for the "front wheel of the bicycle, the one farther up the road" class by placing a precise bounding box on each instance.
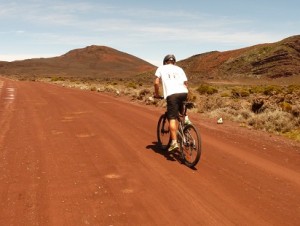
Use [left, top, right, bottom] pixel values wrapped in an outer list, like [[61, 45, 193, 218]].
[[157, 114, 171, 150]]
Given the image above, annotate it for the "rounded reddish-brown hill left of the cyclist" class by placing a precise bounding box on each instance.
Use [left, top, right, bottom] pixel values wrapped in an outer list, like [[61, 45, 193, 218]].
[[0, 45, 155, 78]]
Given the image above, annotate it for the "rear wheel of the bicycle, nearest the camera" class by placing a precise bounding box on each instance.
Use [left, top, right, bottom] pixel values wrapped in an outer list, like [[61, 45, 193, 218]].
[[180, 124, 201, 168]]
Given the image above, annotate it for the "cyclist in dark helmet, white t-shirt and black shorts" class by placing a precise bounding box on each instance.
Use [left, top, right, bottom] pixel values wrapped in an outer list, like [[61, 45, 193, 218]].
[[154, 54, 188, 152]]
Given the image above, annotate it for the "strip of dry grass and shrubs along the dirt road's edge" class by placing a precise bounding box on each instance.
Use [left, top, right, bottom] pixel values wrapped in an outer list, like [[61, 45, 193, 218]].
[[7, 76, 300, 141]]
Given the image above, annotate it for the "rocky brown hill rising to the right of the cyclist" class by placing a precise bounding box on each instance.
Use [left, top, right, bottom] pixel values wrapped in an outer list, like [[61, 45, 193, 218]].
[[178, 35, 300, 82]]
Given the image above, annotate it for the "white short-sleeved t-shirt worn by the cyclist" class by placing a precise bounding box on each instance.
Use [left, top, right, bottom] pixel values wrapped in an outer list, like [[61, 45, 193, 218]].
[[155, 64, 188, 98]]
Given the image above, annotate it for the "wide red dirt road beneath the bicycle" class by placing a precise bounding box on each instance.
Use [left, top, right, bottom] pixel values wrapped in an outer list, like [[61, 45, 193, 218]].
[[0, 78, 300, 226]]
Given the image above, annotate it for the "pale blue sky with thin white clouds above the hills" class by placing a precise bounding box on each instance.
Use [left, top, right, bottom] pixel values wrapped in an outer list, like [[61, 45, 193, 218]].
[[0, 0, 300, 66]]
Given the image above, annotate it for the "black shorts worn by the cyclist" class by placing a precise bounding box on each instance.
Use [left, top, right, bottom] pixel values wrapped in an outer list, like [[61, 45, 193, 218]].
[[167, 93, 187, 119]]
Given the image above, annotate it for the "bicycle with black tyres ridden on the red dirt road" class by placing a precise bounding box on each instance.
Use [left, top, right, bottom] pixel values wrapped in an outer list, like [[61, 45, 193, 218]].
[[157, 101, 202, 168]]
